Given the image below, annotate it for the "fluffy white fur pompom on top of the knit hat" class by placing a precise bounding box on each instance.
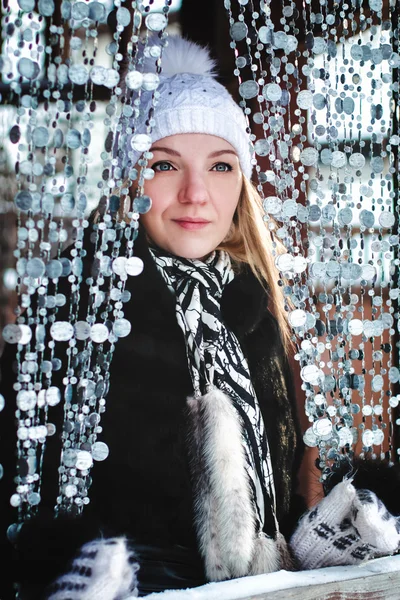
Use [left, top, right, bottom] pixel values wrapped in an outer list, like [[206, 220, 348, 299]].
[[155, 35, 216, 77]]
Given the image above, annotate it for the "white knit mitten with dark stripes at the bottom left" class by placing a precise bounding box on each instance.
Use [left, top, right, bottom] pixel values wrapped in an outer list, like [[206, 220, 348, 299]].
[[47, 537, 139, 600]]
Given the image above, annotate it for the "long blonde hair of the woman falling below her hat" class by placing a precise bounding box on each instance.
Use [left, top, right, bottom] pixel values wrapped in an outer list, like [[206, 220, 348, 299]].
[[92, 175, 292, 352]]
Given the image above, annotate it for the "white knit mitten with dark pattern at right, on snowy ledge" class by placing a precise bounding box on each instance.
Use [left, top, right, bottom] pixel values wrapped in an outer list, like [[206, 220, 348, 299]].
[[290, 480, 400, 569]]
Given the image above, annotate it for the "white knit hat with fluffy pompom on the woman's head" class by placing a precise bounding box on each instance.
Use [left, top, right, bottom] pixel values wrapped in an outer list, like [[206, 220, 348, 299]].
[[115, 36, 252, 179]]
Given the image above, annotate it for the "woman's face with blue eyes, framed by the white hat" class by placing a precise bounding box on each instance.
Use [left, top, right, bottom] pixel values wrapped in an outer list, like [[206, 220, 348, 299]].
[[141, 133, 242, 259]]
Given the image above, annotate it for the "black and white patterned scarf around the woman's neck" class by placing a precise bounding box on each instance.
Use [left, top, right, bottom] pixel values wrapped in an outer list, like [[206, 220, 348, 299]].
[[150, 248, 275, 531]]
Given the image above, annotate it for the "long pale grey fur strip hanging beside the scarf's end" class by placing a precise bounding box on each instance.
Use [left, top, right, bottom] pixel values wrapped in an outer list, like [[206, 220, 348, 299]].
[[189, 389, 255, 581]]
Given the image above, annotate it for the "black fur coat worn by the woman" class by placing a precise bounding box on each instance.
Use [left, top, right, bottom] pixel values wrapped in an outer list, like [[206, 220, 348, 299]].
[[0, 227, 305, 600]]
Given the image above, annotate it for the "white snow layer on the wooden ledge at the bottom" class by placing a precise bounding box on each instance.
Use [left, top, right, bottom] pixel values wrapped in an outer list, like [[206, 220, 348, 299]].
[[127, 555, 400, 600]]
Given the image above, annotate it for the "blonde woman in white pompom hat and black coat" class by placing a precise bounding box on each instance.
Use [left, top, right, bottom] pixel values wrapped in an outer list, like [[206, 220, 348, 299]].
[[0, 38, 398, 600]]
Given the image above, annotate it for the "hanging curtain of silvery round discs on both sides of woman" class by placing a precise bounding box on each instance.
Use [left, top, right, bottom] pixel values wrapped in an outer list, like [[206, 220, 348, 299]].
[[0, 0, 400, 536]]
